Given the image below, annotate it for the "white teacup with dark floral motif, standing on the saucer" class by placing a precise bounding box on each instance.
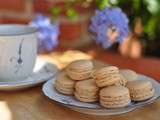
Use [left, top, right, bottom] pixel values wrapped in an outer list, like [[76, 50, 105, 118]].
[[0, 24, 37, 81]]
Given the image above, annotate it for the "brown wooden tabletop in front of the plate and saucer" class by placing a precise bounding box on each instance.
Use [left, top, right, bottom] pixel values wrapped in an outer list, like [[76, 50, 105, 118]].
[[0, 52, 160, 120]]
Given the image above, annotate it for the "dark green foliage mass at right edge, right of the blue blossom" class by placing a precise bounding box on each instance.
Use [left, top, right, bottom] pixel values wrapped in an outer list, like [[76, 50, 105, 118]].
[[113, 0, 160, 56]]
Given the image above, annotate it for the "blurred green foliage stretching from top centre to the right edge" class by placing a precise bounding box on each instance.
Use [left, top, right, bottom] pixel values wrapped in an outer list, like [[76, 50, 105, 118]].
[[50, 0, 160, 56]]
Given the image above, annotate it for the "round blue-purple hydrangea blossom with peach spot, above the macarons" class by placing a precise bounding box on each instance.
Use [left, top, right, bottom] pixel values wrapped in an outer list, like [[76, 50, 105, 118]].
[[89, 7, 129, 48]]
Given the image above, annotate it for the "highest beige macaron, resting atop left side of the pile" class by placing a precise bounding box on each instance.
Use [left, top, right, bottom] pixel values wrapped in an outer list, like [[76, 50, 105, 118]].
[[66, 60, 94, 80]]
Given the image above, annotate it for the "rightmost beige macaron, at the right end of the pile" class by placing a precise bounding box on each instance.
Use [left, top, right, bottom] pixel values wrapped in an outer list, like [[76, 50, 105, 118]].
[[126, 80, 155, 101]]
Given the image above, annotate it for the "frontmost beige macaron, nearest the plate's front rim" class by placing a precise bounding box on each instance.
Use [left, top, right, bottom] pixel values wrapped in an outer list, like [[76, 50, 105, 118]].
[[99, 86, 131, 108]]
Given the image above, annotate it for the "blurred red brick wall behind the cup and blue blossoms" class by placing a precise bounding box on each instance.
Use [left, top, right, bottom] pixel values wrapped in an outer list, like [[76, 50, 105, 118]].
[[0, 0, 93, 45]]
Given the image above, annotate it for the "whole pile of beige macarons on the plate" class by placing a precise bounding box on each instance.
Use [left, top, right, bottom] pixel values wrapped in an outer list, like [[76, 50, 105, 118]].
[[54, 60, 155, 108]]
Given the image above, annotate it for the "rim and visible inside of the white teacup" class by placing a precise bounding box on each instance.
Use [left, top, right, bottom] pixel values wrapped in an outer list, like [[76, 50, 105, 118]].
[[0, 24, 38, 36]]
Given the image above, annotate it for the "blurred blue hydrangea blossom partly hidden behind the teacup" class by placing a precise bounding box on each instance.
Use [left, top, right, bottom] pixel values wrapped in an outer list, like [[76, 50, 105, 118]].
[[30, 14, 59, 53]]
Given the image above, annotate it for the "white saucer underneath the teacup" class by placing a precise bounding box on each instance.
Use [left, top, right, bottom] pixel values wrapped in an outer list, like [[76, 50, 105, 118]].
[[0, 59, 58, 91]]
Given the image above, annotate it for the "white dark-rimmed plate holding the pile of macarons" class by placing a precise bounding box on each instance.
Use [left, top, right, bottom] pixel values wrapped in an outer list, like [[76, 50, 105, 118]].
[[42, 75, 160, 115]]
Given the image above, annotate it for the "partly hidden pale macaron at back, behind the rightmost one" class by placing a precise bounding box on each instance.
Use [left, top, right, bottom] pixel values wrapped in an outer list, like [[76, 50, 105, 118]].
[[120, 69, 138, 81]]
